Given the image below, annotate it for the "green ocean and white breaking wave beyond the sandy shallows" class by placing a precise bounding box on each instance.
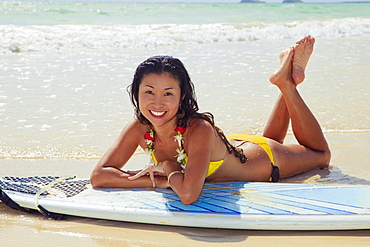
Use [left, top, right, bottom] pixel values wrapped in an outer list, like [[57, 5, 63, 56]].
[[0, 1, 370, 53]]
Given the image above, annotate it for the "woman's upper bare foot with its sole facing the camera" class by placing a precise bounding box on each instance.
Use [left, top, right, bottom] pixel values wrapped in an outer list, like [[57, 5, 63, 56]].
[[292, 36, 315, 85]]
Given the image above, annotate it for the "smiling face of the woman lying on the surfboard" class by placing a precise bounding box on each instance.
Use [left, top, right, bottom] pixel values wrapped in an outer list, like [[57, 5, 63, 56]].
[[139, 72, 181, 127]]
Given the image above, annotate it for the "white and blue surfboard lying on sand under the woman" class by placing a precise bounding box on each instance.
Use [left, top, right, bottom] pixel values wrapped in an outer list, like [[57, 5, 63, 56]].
[[0, 177, 370, 230]]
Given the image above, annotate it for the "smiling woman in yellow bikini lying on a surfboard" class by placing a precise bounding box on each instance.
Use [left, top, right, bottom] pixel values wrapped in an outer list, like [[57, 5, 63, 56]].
[[91, 36, 330, 204]]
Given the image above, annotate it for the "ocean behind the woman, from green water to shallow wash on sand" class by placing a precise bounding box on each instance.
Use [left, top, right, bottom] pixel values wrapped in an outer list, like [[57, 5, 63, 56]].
[[0, 1, 370, 159]]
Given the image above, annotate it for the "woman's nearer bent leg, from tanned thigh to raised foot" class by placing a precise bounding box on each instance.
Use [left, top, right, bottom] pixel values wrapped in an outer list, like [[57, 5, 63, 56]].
[[270, 42, 330, 177]]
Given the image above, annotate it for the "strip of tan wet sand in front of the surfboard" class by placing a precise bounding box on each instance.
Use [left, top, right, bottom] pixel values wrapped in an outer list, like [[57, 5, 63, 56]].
[[0, 205, 370, 247]]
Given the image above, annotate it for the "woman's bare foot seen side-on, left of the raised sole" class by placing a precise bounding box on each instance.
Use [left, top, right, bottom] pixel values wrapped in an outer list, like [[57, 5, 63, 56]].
[[270, 47, 294, 88]]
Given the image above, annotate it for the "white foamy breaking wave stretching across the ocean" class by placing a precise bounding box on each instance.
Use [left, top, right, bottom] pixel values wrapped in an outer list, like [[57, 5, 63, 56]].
[[0, 18, 370, 53]]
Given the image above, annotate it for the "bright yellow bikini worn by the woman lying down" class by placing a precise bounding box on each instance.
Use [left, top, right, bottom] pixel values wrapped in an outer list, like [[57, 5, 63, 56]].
[[152, 134, 274, 178]]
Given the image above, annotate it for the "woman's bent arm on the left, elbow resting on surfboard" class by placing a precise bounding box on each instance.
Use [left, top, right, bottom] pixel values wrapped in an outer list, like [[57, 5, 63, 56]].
[[90, 120, 158, 188]]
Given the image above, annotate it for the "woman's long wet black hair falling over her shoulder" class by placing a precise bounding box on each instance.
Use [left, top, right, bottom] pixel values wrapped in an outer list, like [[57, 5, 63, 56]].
[[127, 56, 247, 163]]
